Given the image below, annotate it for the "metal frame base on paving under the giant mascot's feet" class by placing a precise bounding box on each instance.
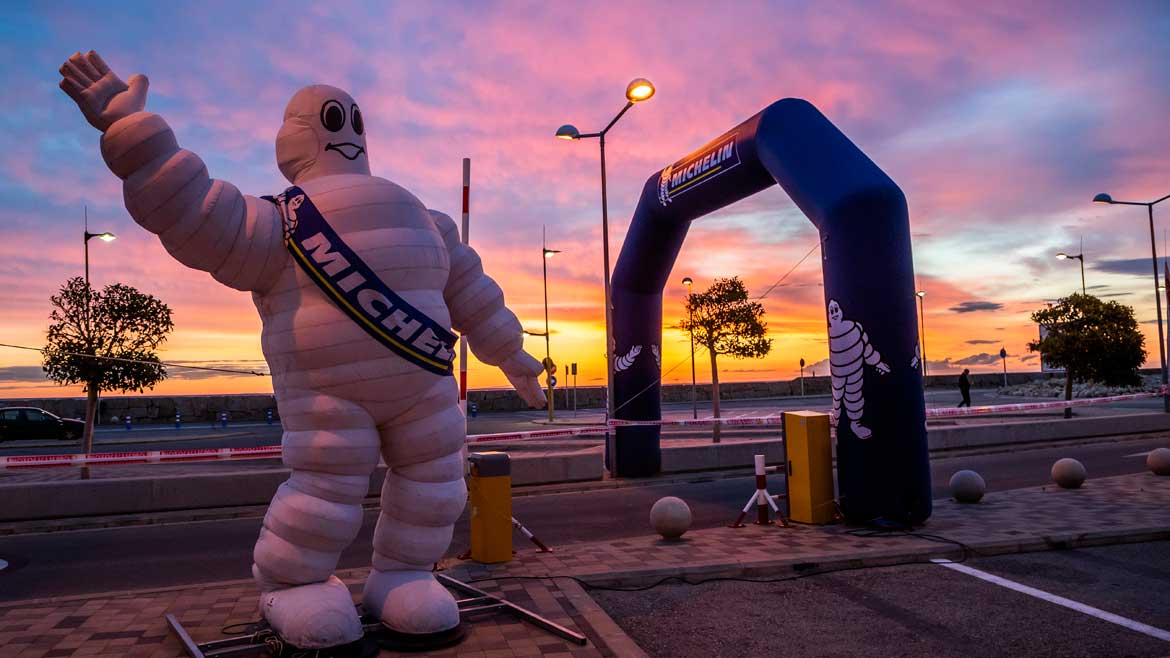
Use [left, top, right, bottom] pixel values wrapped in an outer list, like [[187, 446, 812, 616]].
[[164, 574, 589, 658]]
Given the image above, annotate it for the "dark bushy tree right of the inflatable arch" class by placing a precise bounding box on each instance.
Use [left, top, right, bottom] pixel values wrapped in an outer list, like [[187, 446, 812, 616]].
[[1027, 294, 1145, 418]]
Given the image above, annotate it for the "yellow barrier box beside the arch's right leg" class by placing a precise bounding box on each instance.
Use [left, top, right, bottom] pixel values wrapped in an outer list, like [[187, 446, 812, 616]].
[[784, 411, 834, 523]]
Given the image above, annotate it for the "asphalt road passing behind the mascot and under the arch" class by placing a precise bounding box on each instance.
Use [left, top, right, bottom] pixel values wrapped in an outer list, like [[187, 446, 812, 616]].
[[0, 437, 1170, 599]]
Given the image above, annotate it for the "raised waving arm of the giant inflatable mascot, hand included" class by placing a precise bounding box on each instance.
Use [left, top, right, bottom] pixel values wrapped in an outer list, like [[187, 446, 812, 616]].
[[61, 50, 288, 292]]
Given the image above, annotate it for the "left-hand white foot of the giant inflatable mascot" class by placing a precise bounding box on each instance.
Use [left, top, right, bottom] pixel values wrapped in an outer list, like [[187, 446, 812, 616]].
[[260, 576, 362, 649]]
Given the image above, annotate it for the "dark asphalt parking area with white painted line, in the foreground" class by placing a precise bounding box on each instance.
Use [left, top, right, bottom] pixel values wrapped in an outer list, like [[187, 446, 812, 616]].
[[590, 542, 1170, 658]]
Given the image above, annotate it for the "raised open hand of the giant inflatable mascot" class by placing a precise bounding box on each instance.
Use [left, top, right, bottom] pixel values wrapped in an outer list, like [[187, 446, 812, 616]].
[[60, 50, 150, 132]]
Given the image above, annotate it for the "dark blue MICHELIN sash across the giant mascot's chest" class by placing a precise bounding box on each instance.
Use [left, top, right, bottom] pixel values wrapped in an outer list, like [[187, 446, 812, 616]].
[[264, 186, 456, 375]]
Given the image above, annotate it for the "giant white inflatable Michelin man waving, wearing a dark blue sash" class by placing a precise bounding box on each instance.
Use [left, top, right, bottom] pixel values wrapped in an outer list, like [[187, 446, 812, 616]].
[[61, 52, 545, 649]]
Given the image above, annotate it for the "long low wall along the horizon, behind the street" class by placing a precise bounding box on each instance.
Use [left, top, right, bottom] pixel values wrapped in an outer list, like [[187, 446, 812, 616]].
[[0, 371, 1095, 424]]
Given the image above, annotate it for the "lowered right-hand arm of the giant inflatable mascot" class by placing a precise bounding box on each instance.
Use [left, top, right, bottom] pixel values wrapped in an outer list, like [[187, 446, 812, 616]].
[[431, 211, 548, 407]]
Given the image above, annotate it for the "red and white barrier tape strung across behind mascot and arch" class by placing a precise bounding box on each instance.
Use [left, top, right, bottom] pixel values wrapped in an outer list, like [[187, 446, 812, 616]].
[[0, 389, 1164, 468]]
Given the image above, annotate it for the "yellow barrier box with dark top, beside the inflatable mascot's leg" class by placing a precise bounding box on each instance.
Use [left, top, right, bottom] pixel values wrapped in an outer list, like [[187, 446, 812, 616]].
[[467, 452, 512, 564]]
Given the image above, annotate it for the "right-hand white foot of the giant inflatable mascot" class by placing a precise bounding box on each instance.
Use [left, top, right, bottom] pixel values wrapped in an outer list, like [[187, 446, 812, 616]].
[[362, 569, 459, 635]]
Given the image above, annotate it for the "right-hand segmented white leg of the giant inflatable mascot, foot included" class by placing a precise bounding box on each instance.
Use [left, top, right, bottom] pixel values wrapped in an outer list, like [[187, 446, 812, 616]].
[[362, 377, 467, 635]]
